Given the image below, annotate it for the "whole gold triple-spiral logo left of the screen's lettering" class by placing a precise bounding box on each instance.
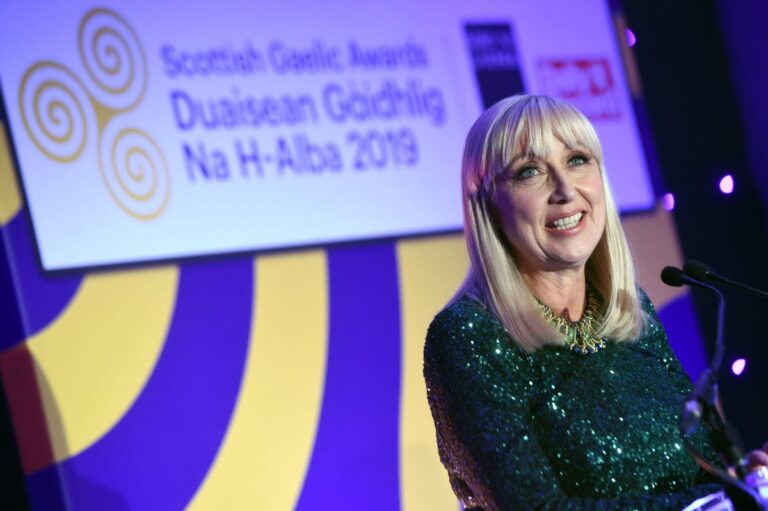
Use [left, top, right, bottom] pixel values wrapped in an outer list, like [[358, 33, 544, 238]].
[[19, 9, 171, 220]]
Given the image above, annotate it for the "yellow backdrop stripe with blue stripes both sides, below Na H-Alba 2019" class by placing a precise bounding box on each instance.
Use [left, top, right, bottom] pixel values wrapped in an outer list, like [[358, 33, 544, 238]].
[[188, 251, 328, 510]]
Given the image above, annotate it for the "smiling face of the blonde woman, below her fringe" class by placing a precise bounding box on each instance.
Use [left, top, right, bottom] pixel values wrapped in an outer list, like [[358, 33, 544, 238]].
[[494, 139, 605, 273]]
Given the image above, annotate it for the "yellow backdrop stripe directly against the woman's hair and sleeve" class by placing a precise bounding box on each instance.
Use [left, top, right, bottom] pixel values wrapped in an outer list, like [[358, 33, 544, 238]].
[[397, 235, 469, 511]]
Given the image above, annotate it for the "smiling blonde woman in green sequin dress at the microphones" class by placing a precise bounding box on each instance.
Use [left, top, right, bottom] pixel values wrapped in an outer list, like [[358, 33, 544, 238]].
[[424, 95, 760, 511]]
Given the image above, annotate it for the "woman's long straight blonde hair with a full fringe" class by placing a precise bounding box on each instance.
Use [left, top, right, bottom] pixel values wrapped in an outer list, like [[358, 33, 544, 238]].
[[454, 94, 646, 352]]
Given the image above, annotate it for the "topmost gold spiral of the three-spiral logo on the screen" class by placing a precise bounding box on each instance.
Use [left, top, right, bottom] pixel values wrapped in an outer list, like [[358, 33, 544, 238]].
[[78, 9, 147, 110]]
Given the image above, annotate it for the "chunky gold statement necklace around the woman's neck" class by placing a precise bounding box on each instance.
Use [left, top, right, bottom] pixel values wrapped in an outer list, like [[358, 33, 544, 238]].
[[536, 286, 605, 355]]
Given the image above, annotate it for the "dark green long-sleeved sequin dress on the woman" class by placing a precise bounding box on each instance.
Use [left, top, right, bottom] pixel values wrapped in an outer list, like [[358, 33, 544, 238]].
[[424, 292, 722, 511]]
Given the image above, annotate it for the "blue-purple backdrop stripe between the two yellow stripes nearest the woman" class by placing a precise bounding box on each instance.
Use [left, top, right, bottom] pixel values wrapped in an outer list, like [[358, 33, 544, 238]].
[[296, 242, 401, 511]]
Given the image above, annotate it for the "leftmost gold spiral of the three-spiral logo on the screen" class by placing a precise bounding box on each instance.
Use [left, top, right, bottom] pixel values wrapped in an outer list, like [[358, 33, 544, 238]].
[[19, 61, 92, 163]]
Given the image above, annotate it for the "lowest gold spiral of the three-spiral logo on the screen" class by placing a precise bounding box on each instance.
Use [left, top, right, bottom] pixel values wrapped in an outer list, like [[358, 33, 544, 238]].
[[101, 128, 170, 220]]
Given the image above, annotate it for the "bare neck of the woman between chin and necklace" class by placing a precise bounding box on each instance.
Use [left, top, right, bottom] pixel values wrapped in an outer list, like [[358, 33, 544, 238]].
[[522, 267, 587, 321]]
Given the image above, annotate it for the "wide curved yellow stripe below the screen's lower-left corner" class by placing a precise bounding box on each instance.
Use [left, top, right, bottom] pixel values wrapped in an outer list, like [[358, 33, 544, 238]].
[[27, 266, 179, 461]]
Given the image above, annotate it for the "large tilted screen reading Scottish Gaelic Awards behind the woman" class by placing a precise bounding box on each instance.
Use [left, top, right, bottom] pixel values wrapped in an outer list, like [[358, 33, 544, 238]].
[[0, 0, 653, 270]]
